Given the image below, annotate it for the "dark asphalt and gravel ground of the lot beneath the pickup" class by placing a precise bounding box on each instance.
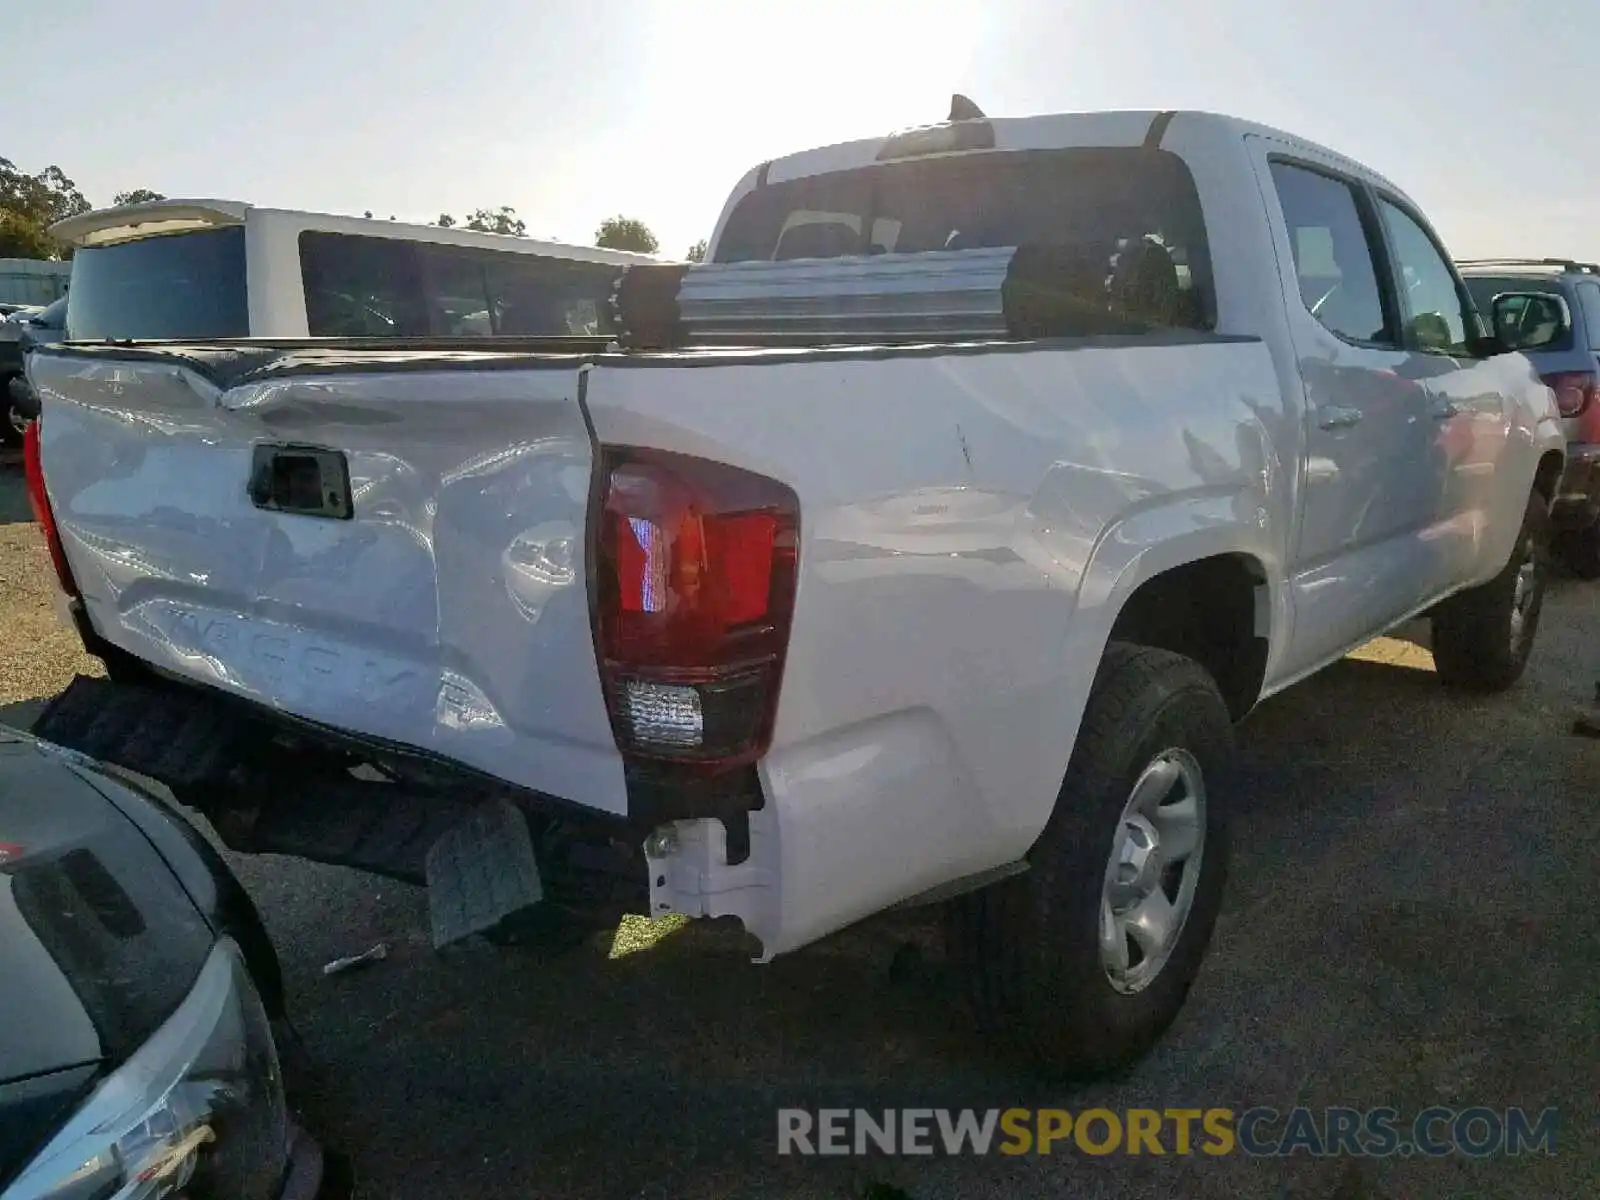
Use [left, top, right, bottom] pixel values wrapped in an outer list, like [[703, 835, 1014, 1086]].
[[0, 469, 1600, 1200]]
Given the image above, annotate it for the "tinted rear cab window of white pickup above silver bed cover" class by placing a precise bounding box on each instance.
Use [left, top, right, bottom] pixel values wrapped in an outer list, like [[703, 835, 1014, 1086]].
[[717, 147, 1214, 328]]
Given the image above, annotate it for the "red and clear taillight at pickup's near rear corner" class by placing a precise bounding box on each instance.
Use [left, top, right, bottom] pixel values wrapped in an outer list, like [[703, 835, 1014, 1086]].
[[592, 446, 800, 771]]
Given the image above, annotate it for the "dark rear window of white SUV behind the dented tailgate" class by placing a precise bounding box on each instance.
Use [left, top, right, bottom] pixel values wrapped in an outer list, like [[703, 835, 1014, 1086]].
[[67, 226, 250, 339]]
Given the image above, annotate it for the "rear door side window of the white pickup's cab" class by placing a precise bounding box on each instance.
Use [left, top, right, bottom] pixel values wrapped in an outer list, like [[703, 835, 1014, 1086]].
[[1272, 163, 1394, 342]]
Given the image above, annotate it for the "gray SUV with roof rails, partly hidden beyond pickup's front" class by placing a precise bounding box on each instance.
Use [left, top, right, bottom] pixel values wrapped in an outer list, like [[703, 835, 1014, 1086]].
[[1458, 258, 1600, 579]]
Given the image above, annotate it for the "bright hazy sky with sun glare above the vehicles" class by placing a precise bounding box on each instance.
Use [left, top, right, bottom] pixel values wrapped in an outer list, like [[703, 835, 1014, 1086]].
[[12, 0, 1600, 259]]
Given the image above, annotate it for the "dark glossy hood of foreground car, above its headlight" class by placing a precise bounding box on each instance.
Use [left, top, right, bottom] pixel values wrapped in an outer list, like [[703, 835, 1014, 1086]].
[[0, 731, 214, 1179]]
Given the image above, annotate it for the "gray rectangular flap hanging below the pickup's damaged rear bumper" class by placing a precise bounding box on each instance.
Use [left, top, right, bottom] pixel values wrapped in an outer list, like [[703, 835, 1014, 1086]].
[[426, 800, 544, 950]]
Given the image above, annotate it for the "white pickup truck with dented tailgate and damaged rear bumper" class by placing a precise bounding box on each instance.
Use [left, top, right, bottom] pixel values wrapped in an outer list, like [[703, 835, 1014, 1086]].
[[29, 112, 1565, 1074]]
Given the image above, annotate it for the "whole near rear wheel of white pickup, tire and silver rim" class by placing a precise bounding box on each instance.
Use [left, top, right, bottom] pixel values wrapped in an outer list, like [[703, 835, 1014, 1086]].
[[949, 643, 1234, 1077]]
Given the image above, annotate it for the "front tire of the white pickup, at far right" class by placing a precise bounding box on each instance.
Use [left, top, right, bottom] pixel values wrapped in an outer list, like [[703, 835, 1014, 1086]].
[[1434, 493, 1550, 691]]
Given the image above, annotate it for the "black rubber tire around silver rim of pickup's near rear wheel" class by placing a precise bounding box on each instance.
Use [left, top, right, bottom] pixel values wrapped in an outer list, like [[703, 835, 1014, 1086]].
[[947, 642, 1234, 1078]]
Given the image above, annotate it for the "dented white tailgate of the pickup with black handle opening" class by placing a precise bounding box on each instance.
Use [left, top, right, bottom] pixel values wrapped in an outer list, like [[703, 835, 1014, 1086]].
[[32, 349, 627, 813]]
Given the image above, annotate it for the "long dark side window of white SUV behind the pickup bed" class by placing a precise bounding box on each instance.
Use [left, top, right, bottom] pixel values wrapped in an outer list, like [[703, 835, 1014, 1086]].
[[299, 230, 621, 338]]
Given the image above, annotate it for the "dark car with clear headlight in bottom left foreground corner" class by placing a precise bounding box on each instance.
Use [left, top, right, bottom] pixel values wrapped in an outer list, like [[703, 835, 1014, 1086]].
[[0, 731, 341, 1200]]
